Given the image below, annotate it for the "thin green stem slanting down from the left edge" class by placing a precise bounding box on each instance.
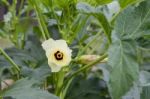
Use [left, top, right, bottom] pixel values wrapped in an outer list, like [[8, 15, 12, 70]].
[[0, 48, 20, 72]]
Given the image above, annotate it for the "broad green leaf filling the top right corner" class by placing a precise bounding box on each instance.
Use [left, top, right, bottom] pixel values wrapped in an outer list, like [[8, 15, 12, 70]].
[[115, 0, 150, 39]]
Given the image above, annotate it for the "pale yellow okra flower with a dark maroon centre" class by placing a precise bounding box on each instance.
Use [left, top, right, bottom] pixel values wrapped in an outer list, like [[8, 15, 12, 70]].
[[42, 39, 72, 72]]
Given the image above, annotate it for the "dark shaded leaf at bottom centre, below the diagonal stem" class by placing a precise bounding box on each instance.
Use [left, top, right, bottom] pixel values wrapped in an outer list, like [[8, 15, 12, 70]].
[[65, 76, 108, 99]]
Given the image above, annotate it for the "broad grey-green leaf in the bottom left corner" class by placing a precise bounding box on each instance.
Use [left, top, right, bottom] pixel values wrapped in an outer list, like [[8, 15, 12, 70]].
[[1, 78, 58, 99]]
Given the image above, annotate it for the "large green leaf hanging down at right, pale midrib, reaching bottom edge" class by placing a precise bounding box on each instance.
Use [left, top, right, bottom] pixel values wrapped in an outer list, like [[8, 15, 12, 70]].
[[108, 40, 139, 99]]
